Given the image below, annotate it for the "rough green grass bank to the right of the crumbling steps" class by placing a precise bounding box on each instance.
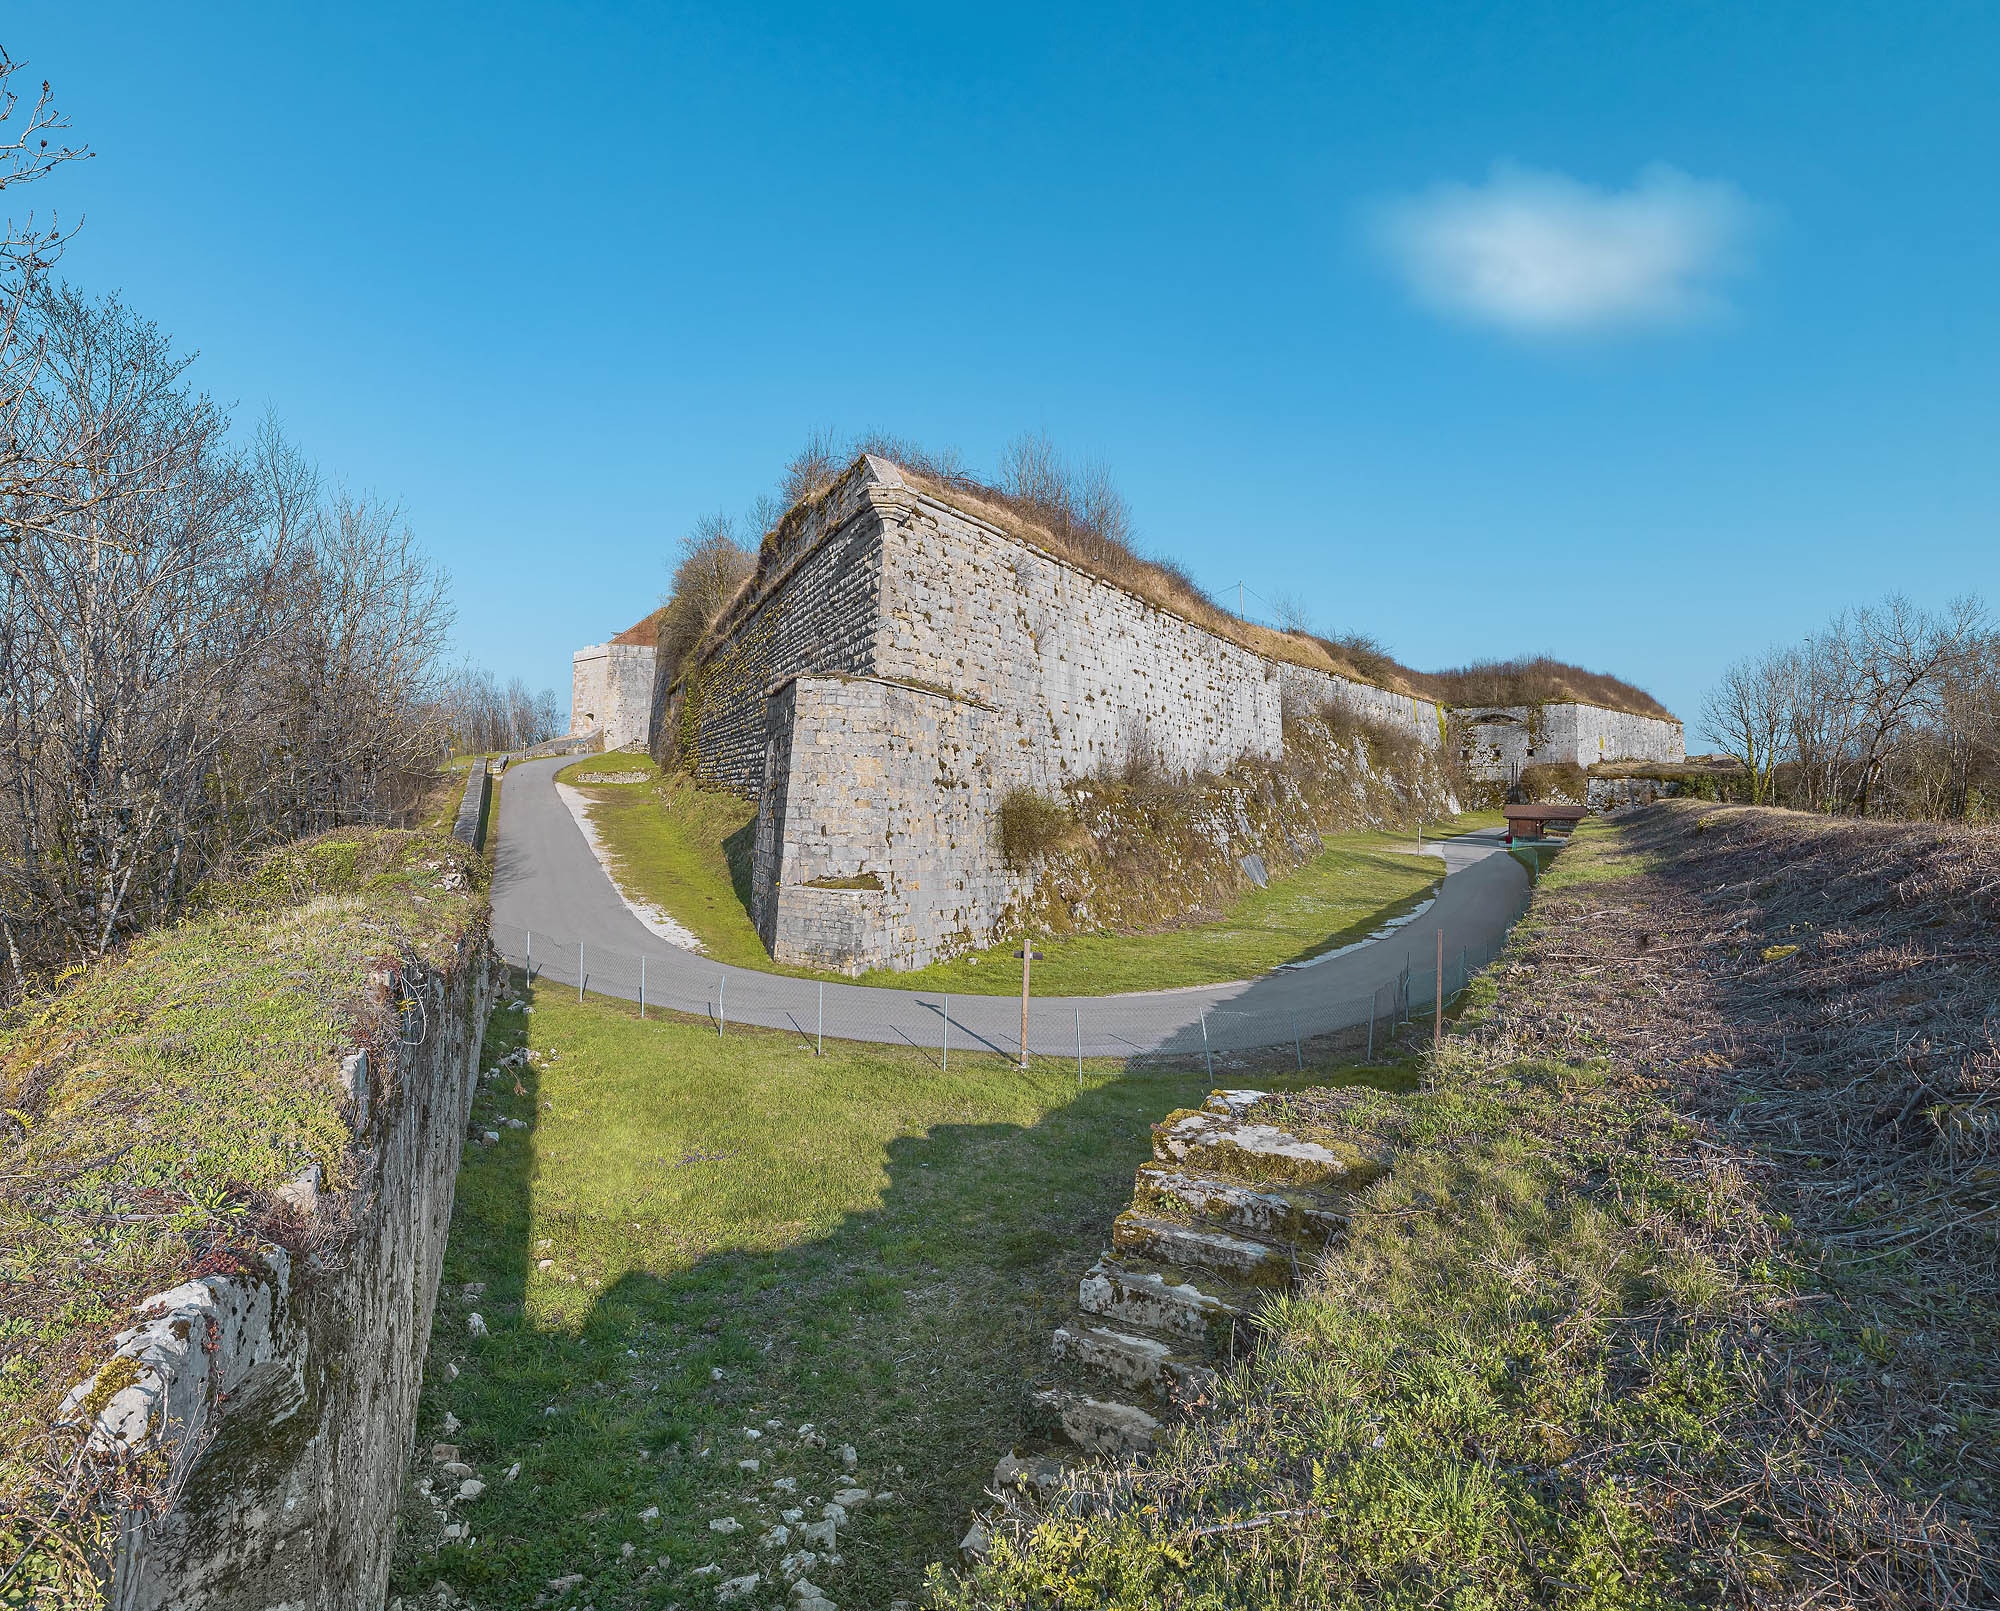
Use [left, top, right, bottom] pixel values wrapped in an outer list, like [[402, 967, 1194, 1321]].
[[936, 823, 2000, 1611]]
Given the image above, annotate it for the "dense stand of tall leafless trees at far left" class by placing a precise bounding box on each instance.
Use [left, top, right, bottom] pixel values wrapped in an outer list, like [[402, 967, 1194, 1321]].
[[0, 284, 450, 997]]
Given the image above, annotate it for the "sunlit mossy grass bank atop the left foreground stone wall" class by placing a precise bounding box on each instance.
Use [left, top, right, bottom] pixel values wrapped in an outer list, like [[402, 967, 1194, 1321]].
[[0, 829, 484, 1605]]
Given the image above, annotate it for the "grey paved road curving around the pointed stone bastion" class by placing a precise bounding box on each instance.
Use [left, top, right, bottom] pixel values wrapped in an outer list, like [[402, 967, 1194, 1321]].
[[494, 756, 1528, 1057]]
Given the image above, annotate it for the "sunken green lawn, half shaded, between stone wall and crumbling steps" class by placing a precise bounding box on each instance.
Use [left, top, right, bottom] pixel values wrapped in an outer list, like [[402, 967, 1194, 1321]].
[[394, 975, 1408, 1611]]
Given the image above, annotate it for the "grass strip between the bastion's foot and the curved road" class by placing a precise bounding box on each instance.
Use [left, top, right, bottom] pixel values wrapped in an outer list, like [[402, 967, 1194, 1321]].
[[558, 754, 1444, 995]]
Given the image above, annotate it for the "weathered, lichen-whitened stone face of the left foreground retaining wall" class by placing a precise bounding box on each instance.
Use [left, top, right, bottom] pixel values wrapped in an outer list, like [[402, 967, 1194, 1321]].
[[66, 939, 490, 1611]]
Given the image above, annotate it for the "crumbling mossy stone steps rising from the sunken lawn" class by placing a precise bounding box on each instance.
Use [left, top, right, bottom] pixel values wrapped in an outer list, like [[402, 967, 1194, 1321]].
[[962, 1091, 1384, 1555]]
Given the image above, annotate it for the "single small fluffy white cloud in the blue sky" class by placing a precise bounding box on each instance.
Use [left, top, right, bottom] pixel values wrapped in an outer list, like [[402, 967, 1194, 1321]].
[[1374, 162, 1756, 332]]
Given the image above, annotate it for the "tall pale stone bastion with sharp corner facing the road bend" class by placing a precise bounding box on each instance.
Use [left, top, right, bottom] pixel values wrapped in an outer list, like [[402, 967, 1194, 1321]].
[[612, 456, 1672, 973]]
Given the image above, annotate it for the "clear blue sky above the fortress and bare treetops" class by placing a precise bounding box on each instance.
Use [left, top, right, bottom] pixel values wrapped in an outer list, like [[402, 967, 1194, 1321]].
[[19, 0, 2000, 722]]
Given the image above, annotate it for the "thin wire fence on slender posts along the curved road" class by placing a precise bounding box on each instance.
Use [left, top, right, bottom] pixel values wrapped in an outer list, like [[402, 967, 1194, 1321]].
[[494, 923, 1496, 1075]]
